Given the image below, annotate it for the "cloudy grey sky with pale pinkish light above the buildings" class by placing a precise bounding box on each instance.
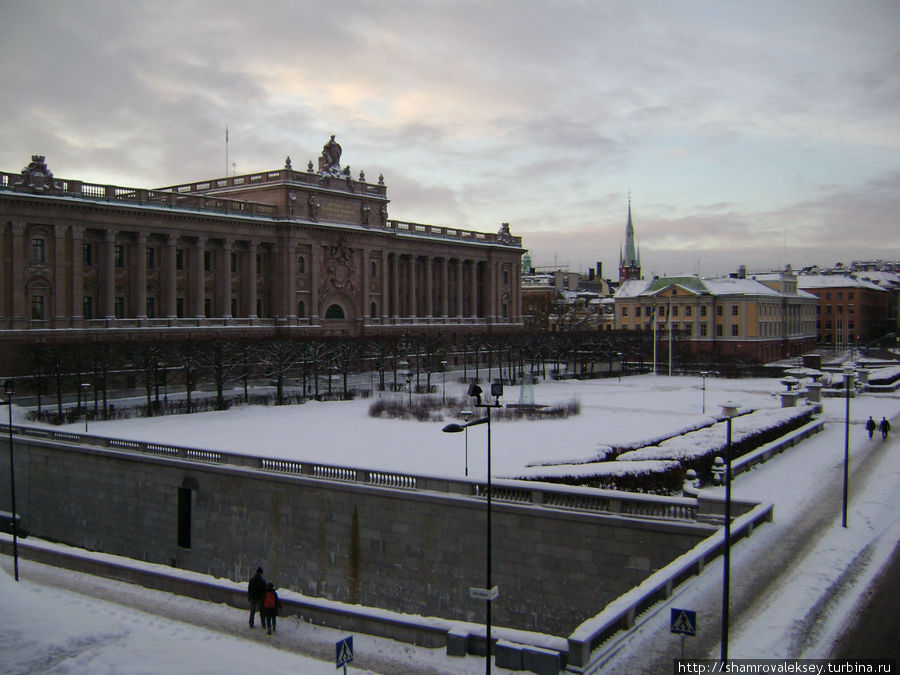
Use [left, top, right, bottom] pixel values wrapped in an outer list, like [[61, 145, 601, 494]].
[[0, 0, 900, 277]]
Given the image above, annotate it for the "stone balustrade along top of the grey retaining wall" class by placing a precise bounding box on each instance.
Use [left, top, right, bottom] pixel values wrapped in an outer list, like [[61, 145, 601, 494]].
[[0, 424, 698, 522]]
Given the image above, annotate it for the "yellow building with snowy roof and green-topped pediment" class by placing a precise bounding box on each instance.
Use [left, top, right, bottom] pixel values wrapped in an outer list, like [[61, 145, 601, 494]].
[[615, 270, 816, 363]]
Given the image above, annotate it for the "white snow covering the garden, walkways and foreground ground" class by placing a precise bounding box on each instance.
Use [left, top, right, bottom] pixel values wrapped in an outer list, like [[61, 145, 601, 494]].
[[0, 375, 900, 673]]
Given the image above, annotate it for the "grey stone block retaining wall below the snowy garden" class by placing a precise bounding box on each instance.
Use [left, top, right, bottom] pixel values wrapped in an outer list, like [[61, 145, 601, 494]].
[[0, 438, 714, 635]]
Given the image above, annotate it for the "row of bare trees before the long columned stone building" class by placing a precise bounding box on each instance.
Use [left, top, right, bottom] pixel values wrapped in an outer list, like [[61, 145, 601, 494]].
[[19, 331, 740, 419]]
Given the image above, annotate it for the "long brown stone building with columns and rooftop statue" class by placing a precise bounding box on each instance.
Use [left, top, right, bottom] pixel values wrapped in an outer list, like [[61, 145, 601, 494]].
[[0, 136, 524, 342]]
